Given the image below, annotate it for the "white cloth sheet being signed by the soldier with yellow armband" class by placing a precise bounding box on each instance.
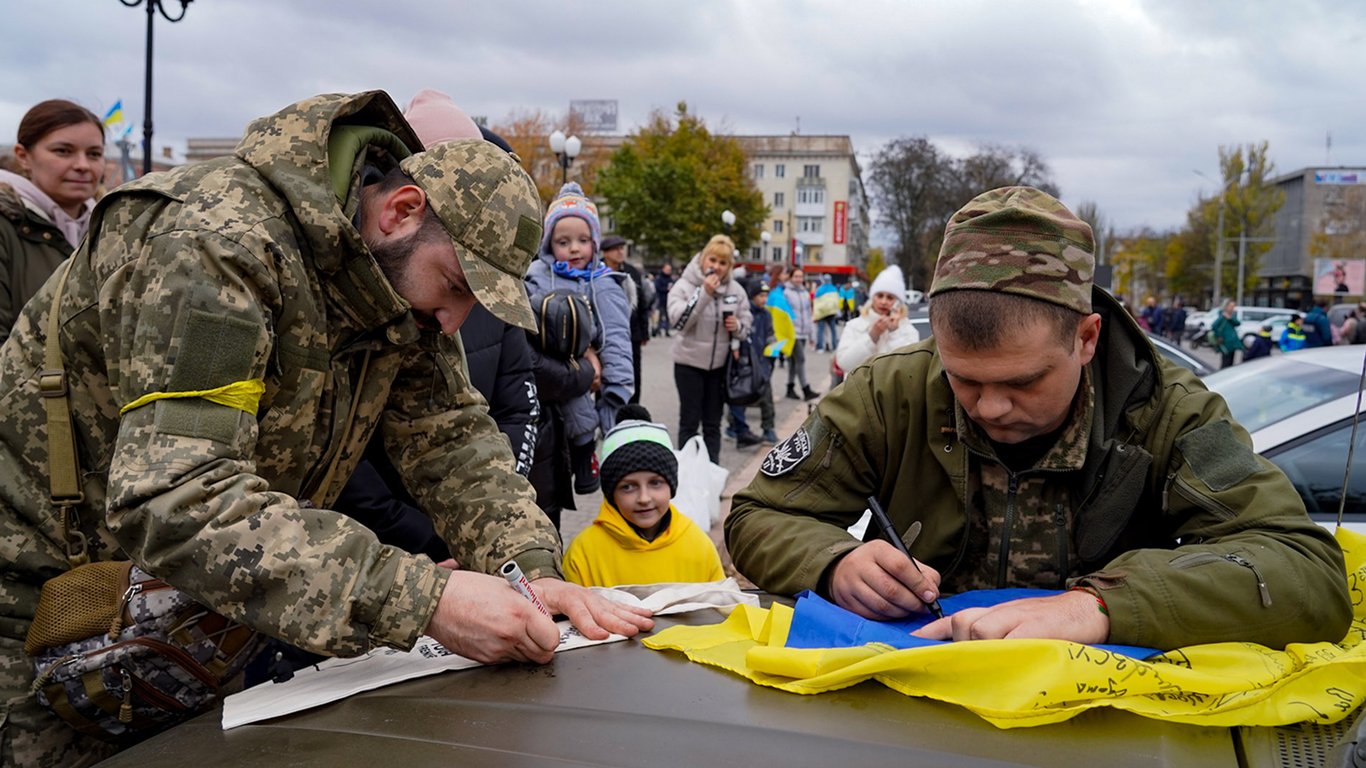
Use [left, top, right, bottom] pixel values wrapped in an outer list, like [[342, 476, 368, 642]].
[[223, 578, 758, 730]]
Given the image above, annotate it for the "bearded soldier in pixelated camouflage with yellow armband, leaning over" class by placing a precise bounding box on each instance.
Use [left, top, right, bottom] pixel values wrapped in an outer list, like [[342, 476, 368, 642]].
[[0, 92, 650, 765]]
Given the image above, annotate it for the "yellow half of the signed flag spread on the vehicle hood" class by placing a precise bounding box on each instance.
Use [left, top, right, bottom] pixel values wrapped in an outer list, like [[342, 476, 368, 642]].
[[645, 529, 1366, 728]]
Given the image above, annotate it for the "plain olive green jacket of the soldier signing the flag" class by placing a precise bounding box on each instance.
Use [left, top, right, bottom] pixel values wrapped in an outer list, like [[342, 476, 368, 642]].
[[725, 291, 1351, 649]]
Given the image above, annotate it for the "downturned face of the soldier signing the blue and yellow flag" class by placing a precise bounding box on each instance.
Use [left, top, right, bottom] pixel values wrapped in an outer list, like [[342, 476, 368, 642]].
[[936, 314, 1100, 443]]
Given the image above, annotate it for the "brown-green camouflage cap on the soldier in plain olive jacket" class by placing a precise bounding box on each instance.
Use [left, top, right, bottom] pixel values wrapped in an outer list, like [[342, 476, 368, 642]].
[[930, 187, 1096, 314]]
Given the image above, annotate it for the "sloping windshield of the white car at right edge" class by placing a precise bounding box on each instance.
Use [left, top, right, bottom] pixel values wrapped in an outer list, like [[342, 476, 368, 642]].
[[1205, 358, 1358, 432]]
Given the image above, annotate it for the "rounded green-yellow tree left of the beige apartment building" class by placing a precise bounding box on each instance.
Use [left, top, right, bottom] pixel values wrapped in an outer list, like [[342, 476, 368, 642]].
[[596, 101, 769, 262]]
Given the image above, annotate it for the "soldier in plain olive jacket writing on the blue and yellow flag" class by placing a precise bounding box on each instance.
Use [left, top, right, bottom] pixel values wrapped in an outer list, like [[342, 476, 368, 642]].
[[725, 187, 1351, 649]]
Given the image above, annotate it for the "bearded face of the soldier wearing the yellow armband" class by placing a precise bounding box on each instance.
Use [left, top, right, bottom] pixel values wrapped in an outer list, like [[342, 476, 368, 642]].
[[366, 219, 478, 333]]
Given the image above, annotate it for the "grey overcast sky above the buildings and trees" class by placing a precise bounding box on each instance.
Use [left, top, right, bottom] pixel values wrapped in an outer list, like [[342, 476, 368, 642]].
[[0, 0, 1366, 231]]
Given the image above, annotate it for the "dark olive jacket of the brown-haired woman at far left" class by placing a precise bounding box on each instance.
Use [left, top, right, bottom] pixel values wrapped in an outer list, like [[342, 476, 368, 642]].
[[0, 183, 72, 344]]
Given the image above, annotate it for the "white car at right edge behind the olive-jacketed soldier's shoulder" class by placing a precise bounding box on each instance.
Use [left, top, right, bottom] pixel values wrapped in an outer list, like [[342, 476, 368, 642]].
[[1205, 346, 1366, 533]]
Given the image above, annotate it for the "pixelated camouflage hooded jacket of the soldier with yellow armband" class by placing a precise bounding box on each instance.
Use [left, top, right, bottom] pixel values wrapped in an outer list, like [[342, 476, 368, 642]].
[[0, 92, 560, 656]]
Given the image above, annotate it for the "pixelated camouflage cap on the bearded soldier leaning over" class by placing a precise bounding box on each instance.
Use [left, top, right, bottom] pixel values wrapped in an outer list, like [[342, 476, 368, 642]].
[[400, 138, 541, 331]]
